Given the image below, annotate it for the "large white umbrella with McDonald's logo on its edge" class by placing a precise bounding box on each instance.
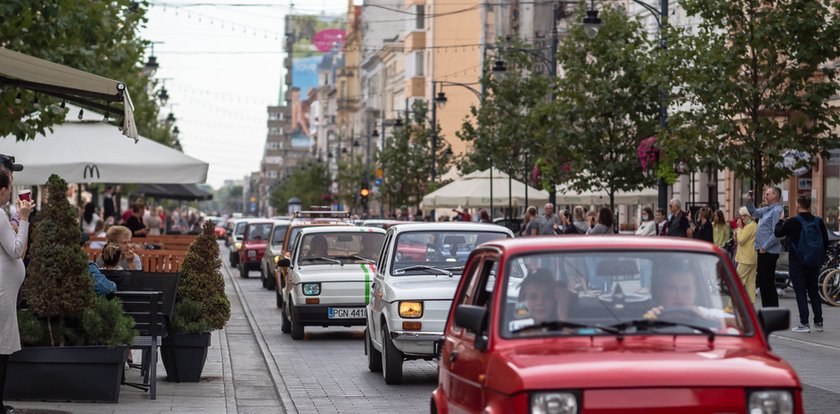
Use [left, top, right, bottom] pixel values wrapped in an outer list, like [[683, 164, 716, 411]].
[[0, 105, 208, 185]]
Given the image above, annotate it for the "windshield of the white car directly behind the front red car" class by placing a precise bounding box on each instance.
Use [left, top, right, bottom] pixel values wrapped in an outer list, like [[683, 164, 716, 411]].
[[391, 230, 507, 276]]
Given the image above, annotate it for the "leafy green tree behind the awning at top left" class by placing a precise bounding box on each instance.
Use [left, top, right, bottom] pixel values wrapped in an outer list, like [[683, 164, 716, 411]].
[[0, 0, 177, 146]]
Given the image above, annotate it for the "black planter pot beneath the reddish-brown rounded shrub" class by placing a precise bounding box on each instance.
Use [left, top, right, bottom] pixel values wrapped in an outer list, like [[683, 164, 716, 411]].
[[160, 332, 210, 382]]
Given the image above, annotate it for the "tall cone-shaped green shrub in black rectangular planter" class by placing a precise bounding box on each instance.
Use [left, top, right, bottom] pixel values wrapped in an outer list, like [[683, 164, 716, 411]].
[[6, 174, 135, 402]]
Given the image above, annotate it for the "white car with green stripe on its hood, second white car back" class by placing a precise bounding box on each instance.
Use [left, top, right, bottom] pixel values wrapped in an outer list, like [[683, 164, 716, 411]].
[[278, 226, 385, 339]]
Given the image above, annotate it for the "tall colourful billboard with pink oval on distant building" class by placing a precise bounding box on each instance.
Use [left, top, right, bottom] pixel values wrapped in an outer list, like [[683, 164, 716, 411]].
[[286, 15, 344, 148]]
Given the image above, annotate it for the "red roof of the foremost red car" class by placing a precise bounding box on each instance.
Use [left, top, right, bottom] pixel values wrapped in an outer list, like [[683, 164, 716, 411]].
[[484, 235, 720, 255]]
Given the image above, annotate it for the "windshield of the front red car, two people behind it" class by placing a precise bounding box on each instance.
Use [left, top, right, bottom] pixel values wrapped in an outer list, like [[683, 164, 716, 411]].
[[502, 251, 753, 338]]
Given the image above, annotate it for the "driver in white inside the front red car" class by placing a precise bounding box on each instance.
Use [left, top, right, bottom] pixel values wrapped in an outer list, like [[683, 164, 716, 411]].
[[644, 270, 733, 323]]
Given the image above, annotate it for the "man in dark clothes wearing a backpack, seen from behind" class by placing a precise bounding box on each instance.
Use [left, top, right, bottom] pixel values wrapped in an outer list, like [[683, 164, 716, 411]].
[[774, 196, 828, 333]]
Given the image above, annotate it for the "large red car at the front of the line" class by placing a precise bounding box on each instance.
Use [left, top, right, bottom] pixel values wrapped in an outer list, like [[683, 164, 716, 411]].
[[431, 236, 803, 414]]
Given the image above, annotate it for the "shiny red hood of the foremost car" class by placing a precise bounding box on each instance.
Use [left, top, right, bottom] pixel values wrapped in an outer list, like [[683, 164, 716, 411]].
[[487, 340, 799, 394]]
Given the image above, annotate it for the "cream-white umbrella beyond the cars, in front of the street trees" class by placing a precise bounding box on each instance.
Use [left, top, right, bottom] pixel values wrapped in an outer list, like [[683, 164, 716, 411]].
[[420, 168, 548, 208]]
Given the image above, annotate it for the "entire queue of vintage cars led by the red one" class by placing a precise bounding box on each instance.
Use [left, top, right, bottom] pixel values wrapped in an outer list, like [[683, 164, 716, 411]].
[[225, 215, 803, 414]]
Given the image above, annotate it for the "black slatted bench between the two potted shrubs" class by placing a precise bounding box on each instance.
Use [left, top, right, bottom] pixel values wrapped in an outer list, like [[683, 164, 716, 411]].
[[108, 270, 181, 400]]
